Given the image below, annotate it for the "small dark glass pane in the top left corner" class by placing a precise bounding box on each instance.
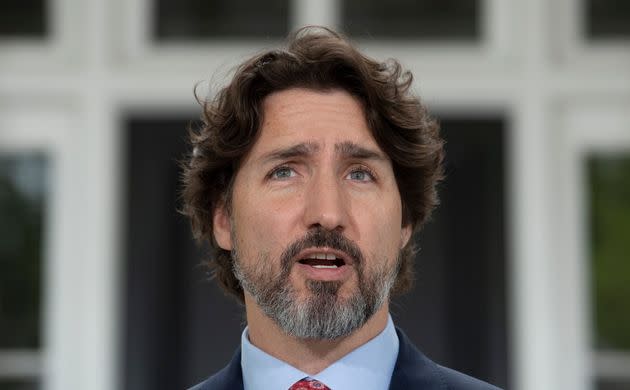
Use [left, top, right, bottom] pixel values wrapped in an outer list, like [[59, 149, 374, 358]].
[[0, 0, 47, 38]]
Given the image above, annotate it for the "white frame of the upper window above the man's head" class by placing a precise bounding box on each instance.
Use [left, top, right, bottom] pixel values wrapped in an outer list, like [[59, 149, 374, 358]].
[[114, 0, 518, 77]]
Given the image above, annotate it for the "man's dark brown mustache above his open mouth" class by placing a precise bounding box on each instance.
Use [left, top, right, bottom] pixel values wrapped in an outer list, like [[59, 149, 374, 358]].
[[280, 227, 363, 272]]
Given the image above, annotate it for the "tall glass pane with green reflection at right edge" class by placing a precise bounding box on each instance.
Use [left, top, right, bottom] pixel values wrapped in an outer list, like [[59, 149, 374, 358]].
[[588, 155, 630, 352]]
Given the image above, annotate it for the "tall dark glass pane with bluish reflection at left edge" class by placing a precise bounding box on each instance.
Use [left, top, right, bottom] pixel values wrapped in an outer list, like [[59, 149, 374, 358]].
[[0, 154, 47, 348]]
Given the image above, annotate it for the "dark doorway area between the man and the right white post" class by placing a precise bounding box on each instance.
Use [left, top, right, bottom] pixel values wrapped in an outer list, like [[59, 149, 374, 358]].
[[391, 119, 509, 388]]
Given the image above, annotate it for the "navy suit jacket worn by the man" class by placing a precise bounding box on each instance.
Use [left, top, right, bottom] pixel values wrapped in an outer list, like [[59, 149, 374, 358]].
[[189, 329, 499, 390]]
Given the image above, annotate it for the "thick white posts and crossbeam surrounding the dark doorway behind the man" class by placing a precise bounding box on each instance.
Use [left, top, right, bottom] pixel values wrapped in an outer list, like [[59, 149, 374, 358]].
[[0, 0, 630, 390]]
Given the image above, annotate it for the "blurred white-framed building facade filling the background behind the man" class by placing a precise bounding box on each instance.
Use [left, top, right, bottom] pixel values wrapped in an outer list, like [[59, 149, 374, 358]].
[[0, 0, 630, 390]]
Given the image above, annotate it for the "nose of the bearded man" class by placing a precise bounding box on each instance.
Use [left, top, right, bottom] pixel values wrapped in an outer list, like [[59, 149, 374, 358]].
[[304, 172, 349, 231]]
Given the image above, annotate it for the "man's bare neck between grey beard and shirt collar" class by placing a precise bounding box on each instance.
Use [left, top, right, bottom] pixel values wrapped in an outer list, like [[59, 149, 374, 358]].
[[245, 293, 389, 375]]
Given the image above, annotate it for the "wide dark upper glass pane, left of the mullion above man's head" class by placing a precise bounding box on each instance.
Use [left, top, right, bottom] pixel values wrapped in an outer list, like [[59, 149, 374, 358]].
[[154, 0, 289, 40]]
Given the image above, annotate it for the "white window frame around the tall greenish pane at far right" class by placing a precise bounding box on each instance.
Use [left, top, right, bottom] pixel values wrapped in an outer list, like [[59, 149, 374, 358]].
[[553, 102, 630, 389]]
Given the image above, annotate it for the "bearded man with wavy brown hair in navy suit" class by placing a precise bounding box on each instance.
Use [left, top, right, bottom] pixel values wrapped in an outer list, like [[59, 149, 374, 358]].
[[184, 28, 504, 390]]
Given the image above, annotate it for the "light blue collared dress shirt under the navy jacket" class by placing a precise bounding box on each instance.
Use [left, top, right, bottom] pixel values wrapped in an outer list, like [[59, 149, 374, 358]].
[[241, 316, 398, 390]]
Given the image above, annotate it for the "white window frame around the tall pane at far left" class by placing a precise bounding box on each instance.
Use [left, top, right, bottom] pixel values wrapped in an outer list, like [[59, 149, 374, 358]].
[[0, 99, 83, 388]]
